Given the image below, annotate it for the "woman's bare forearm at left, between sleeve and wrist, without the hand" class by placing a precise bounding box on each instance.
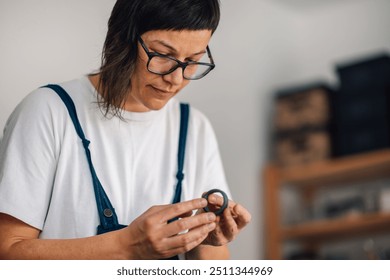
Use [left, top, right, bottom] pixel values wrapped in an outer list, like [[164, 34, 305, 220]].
[[1, 230, 129, 260]]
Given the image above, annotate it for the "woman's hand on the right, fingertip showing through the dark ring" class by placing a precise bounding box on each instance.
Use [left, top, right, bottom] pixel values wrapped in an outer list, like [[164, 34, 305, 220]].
[[202, 194, 251, 246]]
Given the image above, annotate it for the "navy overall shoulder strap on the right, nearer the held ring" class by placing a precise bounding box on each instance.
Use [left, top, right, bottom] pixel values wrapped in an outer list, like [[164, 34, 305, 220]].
[[172, 103, 190, 203]]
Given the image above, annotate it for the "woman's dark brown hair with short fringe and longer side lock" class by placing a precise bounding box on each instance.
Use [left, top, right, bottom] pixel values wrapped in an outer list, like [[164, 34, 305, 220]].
[[98, 0, 220, 117]]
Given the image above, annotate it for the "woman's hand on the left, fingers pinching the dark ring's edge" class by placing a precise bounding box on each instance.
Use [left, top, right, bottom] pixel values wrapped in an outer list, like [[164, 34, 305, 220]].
[[118, 198, 216, 259]]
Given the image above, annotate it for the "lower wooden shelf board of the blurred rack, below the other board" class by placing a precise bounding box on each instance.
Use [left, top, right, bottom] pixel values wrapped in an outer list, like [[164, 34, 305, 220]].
[[281, 213, 390, 241]]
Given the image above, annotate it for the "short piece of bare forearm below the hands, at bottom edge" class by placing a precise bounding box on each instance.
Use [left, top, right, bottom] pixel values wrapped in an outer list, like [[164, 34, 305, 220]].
[[186, 245, 230, 260]]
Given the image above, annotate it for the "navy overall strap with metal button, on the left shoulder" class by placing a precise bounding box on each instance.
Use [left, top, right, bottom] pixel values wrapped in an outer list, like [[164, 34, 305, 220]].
[[44, 84, 124, 234]]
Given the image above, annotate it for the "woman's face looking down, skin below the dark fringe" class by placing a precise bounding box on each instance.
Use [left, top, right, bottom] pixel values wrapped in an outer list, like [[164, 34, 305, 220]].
[[125, 30, 211, 112]]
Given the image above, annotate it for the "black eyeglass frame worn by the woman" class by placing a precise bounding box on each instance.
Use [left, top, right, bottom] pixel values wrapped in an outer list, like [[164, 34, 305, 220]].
[[138, 36, 215, 80]]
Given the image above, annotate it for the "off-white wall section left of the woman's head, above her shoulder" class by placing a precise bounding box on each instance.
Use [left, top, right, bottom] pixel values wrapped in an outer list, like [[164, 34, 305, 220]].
[[0, 0, 115, 131]]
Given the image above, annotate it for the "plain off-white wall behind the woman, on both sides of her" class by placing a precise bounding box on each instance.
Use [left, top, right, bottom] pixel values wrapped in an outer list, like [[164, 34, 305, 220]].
[[0, 0, 390, 259]]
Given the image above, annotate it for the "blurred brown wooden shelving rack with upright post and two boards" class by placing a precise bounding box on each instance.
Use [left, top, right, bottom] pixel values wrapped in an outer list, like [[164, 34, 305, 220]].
[[263, 149, 390, 259]]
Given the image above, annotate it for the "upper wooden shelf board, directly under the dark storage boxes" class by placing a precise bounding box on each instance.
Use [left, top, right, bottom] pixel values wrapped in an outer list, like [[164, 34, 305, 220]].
[[280, 149, 390, 186]]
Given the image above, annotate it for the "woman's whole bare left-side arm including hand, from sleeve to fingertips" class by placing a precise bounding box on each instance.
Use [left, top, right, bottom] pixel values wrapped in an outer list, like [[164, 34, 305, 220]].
[[0, 199, 215, 259]]
